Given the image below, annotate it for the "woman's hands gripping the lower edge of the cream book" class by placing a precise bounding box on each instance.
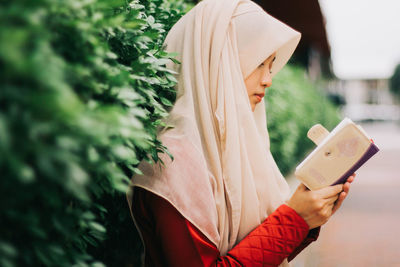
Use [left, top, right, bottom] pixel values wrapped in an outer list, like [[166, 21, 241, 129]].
[[287, 174, 355, 229]]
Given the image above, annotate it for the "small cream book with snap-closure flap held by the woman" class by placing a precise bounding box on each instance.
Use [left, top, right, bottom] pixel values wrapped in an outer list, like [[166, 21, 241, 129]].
[[295, 118, 379, 190]]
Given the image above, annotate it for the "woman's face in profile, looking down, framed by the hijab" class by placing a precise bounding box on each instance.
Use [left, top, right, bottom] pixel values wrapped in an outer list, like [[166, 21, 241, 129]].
[[244, 53, 276, 111]]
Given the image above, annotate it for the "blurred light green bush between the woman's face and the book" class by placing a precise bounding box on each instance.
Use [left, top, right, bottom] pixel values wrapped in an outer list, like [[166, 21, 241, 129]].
[[266, 65, 339, 174]]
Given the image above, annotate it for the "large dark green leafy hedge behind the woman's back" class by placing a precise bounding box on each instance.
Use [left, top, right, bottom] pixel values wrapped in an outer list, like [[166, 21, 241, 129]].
[[0, 0, 187, 266]]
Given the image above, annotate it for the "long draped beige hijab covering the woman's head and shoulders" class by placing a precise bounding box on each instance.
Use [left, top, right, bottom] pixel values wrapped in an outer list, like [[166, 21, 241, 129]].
[[128, 0, 300, 265]]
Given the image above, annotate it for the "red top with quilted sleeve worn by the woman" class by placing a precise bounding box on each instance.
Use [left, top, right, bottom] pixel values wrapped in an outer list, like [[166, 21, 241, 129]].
[[132, 188, 319, 267]]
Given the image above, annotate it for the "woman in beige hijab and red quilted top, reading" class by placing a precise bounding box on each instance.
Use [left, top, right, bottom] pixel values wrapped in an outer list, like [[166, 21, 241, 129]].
[[128, 0, 354, 266]]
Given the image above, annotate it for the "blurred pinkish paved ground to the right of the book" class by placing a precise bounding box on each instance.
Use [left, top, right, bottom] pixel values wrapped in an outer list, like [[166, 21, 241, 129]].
[[289, 123, 400, 267]]
